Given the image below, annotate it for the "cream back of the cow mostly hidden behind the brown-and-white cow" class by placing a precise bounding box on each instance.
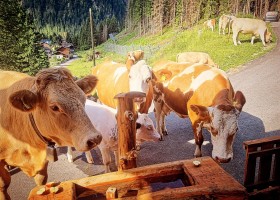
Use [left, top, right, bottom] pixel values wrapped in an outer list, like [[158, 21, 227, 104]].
[[176, 52, 219, 68]]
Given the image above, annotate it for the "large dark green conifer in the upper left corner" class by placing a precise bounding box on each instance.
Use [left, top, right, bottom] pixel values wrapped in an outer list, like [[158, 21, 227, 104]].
[[0, 0, 49, 75]]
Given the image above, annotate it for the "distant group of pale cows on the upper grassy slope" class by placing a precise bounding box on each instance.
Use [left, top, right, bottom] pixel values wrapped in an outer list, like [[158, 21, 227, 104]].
[[204, 14, 272, 46]]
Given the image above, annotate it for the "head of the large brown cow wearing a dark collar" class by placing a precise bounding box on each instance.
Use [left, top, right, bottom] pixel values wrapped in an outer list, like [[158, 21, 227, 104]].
[[9, 68, 102, 151]]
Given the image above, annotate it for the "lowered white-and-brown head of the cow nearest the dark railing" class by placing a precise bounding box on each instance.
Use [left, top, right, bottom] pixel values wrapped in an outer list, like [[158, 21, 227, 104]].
[[190, 91, 246, 162]]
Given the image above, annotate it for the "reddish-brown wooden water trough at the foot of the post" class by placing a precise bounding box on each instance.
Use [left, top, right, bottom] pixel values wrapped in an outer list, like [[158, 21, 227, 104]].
[[29, 157, 247, 200]]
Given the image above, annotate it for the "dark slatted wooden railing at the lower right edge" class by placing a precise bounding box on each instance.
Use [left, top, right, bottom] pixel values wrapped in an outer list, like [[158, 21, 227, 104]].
[[243, 136, 280, 192]]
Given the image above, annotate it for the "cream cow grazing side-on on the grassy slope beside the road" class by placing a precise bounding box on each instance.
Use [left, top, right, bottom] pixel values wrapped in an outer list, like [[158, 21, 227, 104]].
[[232, 18, 271, 46]]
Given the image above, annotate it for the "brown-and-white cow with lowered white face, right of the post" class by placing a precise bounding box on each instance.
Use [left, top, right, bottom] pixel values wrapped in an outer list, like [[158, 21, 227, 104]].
[[152, 65, 245, 162]]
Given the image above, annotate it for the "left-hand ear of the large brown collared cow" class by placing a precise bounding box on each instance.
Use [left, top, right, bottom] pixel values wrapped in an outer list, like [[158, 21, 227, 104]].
[[9, 90, 38, 112]]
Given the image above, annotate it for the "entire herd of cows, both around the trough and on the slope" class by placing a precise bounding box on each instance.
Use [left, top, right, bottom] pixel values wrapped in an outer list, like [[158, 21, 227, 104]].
[[0, 15, 270, 199]]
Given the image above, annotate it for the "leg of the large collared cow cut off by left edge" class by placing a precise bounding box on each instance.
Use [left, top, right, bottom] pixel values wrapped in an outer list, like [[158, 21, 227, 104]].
[[0, 161, 11, 200]]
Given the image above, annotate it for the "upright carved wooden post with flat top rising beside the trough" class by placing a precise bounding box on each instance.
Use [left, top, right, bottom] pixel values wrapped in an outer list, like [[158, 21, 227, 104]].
[[114, 92, 146, 171]]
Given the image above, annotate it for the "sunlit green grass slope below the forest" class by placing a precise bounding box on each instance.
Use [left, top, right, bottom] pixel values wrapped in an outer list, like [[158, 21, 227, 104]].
[[66, 22, 276, 77]]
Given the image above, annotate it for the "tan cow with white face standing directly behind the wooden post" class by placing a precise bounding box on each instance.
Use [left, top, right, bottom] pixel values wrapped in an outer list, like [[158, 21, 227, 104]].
[[92, 50, 152, 113]]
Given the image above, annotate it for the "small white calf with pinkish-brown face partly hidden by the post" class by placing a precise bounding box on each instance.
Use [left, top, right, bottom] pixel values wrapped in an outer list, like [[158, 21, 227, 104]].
[[67, 100, 160, 173]]
